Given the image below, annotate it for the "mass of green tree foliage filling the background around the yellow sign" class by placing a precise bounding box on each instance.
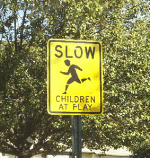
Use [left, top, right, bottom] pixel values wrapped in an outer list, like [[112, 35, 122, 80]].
[[0, 0, 150, 157]]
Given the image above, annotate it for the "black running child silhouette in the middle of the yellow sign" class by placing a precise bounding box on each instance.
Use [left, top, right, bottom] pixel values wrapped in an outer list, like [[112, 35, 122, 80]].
[[60, 60, 91, 94]]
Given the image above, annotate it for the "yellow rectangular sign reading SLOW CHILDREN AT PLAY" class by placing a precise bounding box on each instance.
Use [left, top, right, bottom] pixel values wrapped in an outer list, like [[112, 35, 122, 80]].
[[47, 39, 103, 115]]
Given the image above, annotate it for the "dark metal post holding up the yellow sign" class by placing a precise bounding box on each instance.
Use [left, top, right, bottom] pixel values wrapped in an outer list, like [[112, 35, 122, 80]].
[[71, 115, 82, 158]]
